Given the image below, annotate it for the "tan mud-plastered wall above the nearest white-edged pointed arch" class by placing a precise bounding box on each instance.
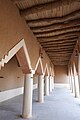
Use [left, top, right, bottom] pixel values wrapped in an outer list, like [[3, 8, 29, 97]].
[[0, 0, 49, 69]]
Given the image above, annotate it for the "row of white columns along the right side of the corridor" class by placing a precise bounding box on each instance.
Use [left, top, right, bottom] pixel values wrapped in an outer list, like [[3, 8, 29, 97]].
[[69, 55, 80, 98]]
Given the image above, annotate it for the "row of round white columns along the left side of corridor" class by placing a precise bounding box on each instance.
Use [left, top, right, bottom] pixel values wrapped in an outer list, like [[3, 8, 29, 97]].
[[22, 74, 54, 118]]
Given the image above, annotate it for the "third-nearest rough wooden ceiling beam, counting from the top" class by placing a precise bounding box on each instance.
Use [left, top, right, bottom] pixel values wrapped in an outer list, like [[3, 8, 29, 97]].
[[31, 19, 80, 33]]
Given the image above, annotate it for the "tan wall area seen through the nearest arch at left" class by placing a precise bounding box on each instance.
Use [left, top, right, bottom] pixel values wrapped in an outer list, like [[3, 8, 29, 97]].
[[0, 57, 24, 91]]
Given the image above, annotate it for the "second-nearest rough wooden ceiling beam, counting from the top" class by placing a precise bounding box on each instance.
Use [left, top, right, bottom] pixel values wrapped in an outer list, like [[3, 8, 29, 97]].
[[27, 10, 80, 28]]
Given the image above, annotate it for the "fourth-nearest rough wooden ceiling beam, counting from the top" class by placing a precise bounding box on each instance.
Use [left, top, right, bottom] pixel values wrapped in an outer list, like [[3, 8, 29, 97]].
[[34, 26, 80, 37]]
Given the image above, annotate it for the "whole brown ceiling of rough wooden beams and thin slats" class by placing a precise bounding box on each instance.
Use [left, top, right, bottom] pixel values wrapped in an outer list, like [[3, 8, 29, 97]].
[[12, 0, 80, 65]]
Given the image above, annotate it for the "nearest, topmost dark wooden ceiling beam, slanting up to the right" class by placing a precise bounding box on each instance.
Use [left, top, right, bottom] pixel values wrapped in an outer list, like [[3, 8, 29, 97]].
[[20, 0, 80, 17]]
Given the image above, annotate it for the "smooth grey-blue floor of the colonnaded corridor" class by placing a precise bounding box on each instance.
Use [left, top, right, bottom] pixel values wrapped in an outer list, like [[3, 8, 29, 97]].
[[0, 88, 80, 120]]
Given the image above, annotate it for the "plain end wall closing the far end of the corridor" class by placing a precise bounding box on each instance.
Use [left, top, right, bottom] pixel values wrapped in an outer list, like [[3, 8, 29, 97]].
[[54, 66, 68, 83]]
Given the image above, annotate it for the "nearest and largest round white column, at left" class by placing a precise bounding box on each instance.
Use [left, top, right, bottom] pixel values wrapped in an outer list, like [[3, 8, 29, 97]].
[[22, 73, 33, 118]]
